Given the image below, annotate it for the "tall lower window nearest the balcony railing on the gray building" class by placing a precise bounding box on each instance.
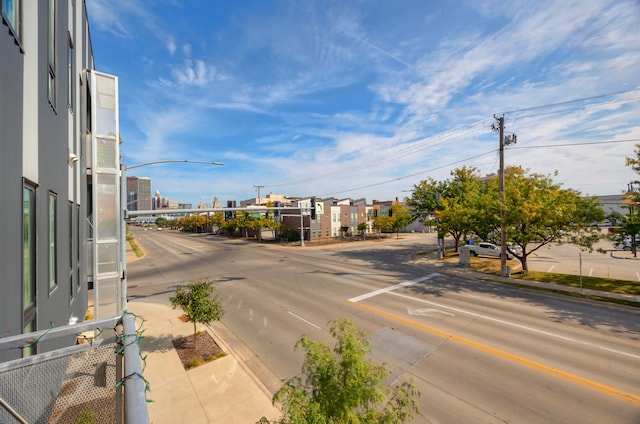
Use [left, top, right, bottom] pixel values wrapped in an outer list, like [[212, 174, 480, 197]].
[[22, 184, 36, 314]]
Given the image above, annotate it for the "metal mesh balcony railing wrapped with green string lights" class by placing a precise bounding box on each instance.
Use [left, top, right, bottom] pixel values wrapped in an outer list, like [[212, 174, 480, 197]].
[[0, 312, 149, 424]]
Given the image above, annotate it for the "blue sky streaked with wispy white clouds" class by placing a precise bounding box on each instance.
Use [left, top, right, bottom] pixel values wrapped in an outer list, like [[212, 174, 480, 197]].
[[86, 0, 640, 206]]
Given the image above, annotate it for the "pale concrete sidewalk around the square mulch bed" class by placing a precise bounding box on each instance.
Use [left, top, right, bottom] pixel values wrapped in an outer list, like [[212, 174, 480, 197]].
[[129, 302, 281, 424]]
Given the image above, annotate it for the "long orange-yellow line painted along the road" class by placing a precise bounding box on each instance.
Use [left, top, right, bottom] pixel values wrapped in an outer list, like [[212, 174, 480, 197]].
[[347, 301, 640, 405]]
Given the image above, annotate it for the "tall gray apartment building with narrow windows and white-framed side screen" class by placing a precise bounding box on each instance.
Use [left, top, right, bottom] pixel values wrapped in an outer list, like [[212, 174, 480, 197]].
[[0, 0, 122, 361]]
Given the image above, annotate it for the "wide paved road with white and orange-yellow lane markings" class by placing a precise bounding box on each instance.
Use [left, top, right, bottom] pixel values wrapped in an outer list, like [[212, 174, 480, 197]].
[[129, 232, 640, 423]]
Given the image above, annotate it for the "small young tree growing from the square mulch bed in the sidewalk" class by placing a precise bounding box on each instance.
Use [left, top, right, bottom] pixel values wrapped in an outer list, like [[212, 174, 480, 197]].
[[169, 279, 224, 347]]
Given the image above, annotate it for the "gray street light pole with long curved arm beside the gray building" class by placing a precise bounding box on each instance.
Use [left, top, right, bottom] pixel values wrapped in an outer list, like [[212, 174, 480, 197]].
[[118, 159, 224, 312]]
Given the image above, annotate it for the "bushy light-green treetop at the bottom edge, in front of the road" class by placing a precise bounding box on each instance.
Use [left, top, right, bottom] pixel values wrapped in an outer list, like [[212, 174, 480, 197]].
[[260, 320, 420, 424]]
